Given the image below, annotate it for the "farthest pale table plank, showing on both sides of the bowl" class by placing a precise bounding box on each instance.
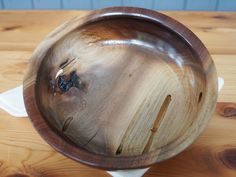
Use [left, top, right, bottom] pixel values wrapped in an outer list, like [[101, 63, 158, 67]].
[[0, 11, 236, 54]]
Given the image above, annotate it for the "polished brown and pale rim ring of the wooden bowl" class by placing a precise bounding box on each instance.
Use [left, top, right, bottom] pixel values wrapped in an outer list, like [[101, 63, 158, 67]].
[[23, 7, 218, 170]]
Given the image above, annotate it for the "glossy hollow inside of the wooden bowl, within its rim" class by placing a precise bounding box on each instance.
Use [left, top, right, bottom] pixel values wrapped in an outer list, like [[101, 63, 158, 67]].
[[35, 16, 206, 157]]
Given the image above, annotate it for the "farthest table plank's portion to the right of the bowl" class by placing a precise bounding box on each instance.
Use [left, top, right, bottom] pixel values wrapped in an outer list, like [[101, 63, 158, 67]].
[[171, 12, 236, 54]]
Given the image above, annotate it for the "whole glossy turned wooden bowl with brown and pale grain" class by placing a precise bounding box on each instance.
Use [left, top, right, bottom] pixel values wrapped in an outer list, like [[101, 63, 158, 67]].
[[24, 7, 217, 170]]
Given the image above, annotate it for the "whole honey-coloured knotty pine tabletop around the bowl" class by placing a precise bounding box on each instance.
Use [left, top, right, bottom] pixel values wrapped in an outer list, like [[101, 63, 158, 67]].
[[0, 11, 236, 177]]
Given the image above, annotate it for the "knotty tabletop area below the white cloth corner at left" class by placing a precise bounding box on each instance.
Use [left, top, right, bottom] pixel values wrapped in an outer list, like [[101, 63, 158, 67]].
[[0, 112, 109, 177]]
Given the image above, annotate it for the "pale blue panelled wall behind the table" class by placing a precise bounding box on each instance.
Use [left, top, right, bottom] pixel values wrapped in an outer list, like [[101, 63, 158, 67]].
[[0, 0, 236, 11]]
